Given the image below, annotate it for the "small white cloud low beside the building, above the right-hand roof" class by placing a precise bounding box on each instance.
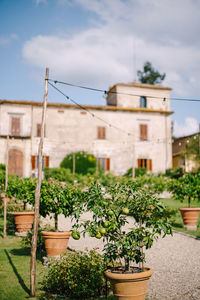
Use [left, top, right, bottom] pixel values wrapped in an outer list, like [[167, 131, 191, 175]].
[[173, 117, 199, 137]]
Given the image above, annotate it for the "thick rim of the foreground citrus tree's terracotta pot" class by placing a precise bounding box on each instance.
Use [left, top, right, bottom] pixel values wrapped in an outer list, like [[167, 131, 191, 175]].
[[105, 267, 153, 280]]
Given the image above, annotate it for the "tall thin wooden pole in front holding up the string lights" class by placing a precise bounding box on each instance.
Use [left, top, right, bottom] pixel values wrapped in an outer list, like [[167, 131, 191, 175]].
[[30, 68, 49, 297]]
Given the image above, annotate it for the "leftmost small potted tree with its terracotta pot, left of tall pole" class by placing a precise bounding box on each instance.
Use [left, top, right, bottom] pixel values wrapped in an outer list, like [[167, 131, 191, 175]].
[[6, 175, 36, 235]]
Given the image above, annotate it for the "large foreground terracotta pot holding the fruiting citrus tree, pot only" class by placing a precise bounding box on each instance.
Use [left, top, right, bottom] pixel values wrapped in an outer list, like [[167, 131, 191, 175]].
[[105, 268, 153, 300]]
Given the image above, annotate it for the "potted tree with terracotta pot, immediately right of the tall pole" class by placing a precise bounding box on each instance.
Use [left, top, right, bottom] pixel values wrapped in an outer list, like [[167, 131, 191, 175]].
[[40, 180, 78, 256]]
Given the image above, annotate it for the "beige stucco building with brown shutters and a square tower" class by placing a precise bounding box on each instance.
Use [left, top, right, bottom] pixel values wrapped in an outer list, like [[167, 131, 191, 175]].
[[0, 82, 172, 177]]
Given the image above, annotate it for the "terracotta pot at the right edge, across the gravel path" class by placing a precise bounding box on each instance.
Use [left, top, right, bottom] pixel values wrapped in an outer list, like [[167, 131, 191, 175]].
[[179, 207, 200, 230]]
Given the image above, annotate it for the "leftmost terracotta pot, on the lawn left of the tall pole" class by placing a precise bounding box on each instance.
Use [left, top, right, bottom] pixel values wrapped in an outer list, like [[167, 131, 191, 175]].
[[11, 211, 34, 232]]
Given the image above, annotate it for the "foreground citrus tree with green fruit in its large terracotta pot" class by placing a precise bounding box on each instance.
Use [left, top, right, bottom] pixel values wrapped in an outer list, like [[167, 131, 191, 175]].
[[74, 181, 172, 300]]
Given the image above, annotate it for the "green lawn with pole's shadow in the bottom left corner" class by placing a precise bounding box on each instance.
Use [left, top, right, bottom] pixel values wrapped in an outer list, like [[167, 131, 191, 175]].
[[0, 231, 44, 300]]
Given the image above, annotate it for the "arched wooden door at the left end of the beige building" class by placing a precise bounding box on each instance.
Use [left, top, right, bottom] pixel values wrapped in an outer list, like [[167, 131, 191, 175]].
[[8, 149, 23, 176]]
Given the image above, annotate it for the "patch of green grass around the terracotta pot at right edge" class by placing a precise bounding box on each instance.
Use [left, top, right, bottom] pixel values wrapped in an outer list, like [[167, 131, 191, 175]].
[[162, 198, 200, 238]]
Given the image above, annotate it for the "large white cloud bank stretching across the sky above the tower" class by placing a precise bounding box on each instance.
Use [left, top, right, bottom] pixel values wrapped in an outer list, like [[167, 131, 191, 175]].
[[23, 0, 200, 97]]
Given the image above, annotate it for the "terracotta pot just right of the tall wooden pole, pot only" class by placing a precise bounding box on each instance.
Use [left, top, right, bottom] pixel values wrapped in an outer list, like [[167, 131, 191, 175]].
[[41, 231, 71, 256]]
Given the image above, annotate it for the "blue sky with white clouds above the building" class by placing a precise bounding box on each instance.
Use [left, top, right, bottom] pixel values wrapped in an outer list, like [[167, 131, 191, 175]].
[[0, 0, 200, 137]]
